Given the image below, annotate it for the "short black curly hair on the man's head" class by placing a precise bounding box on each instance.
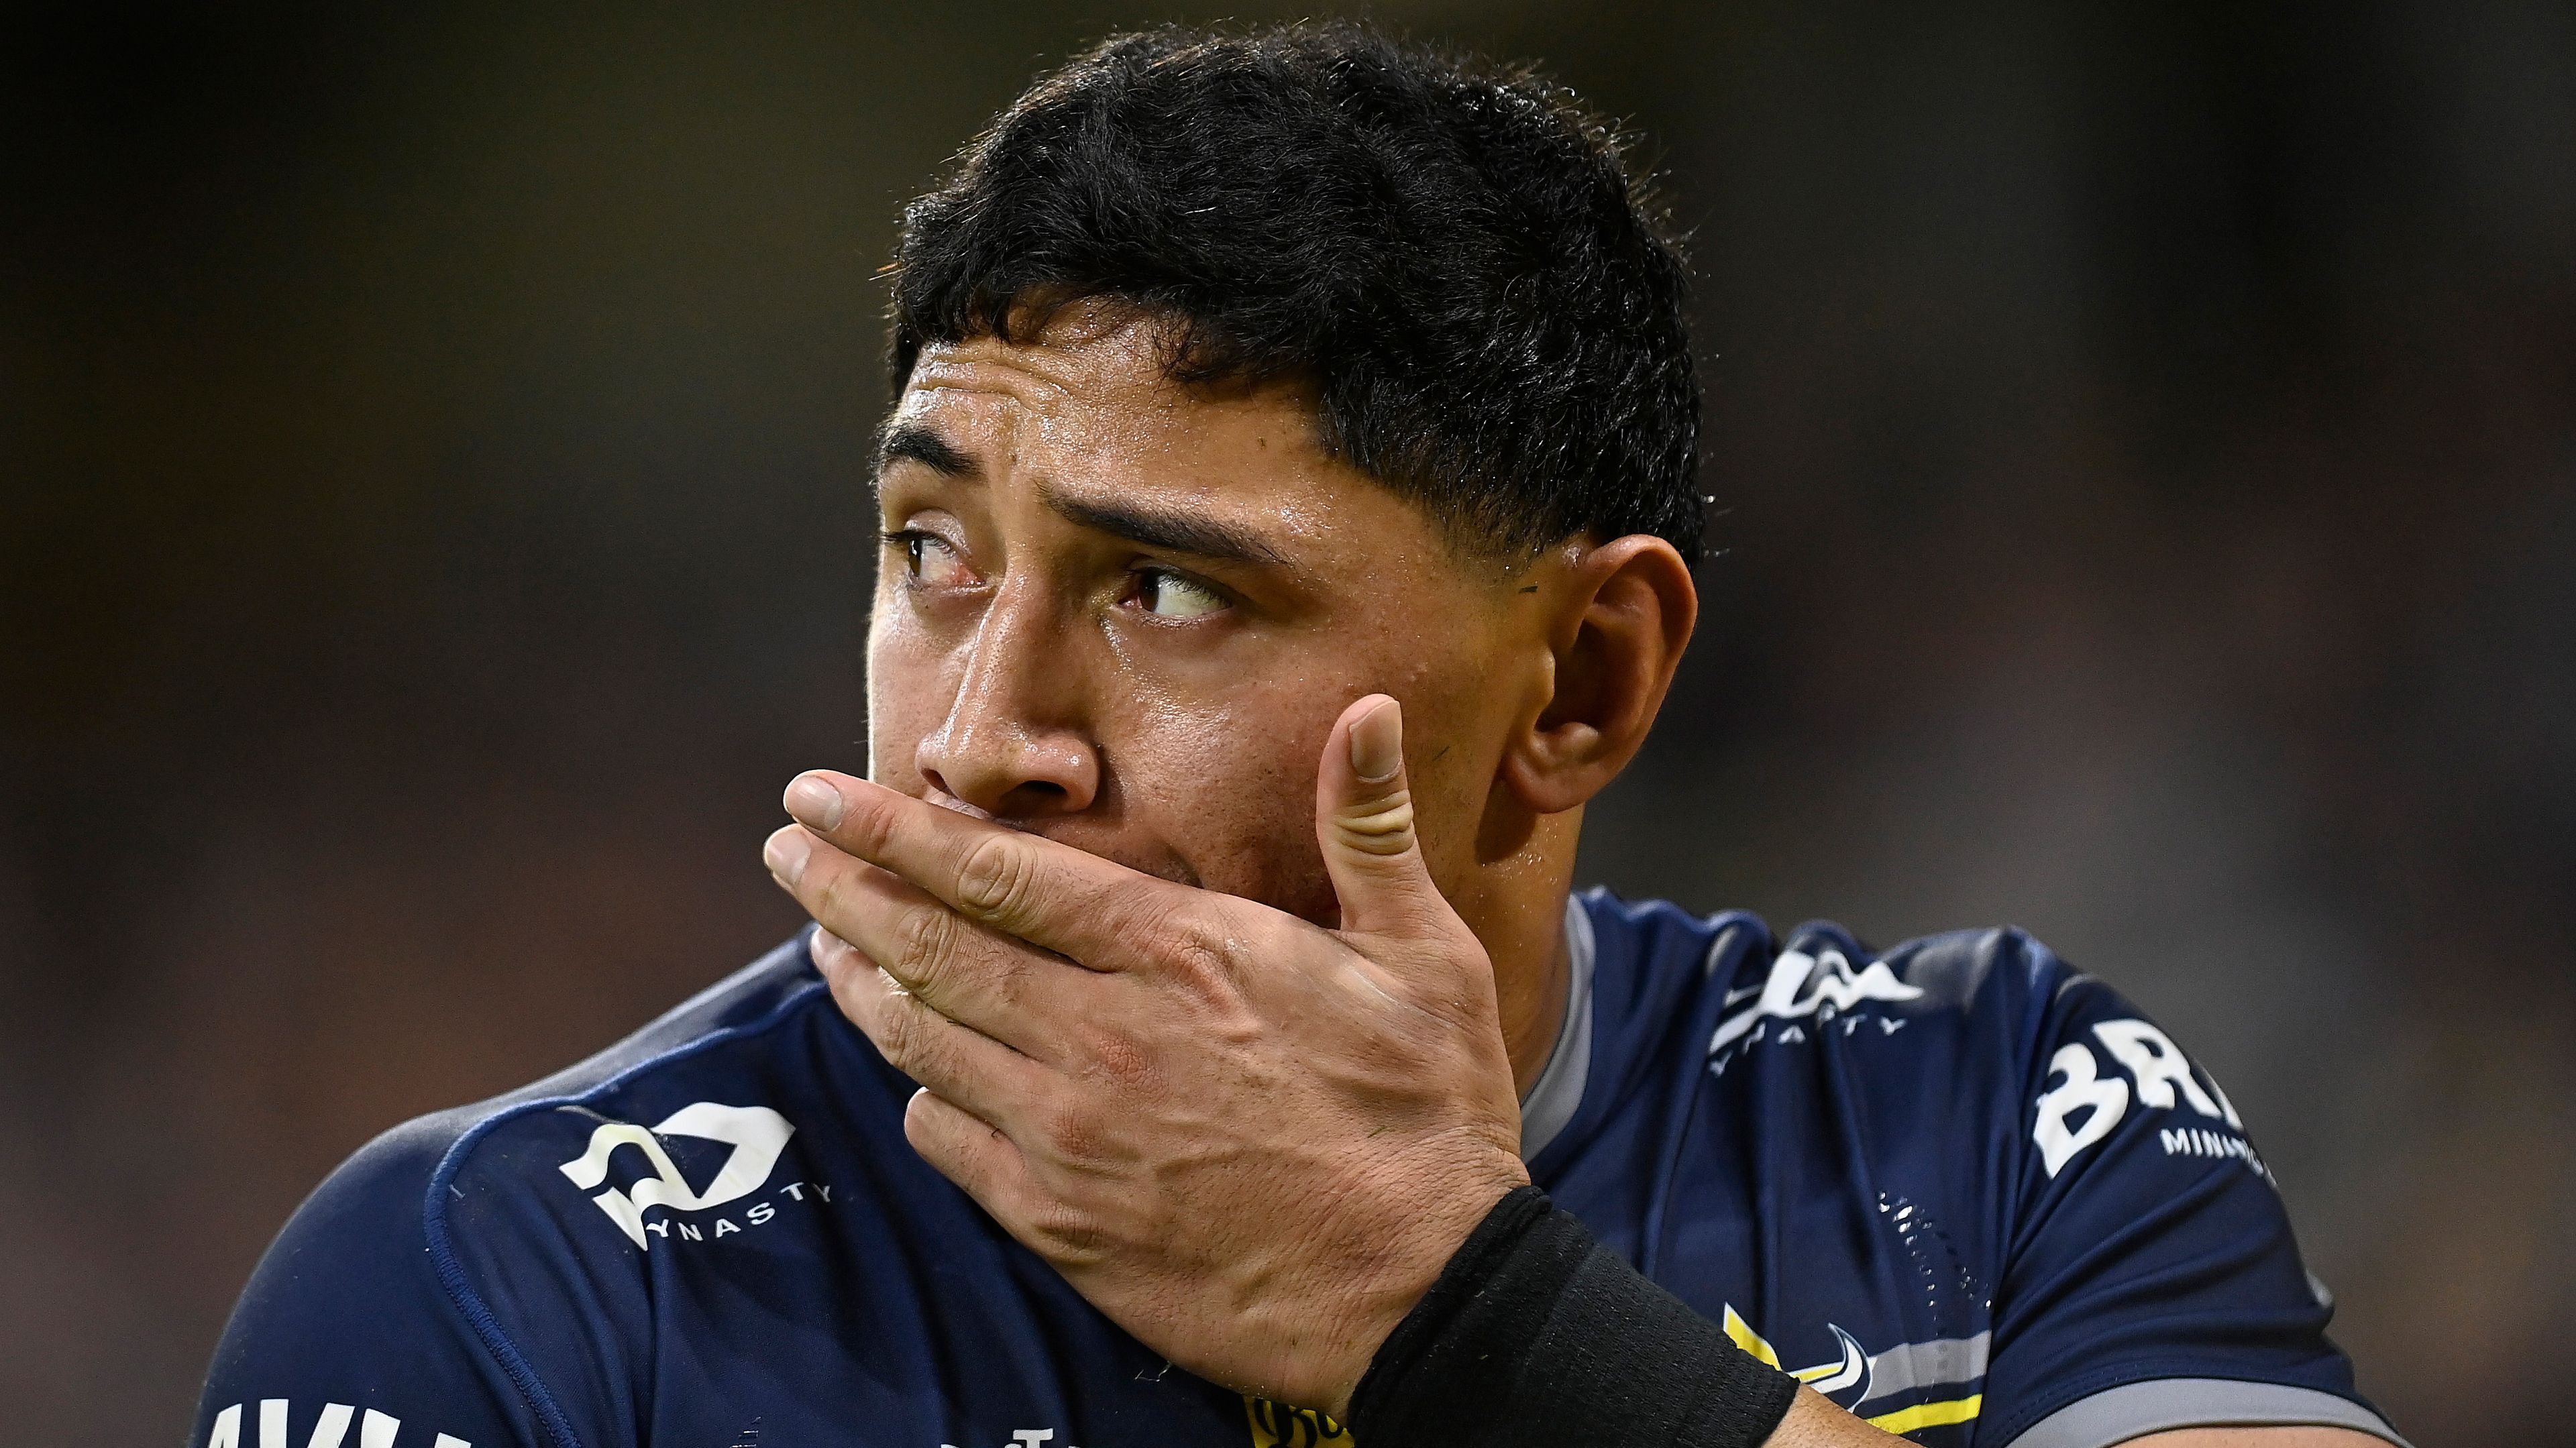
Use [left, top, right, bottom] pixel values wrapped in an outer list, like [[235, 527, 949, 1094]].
[[889, 23, 1703, 561]]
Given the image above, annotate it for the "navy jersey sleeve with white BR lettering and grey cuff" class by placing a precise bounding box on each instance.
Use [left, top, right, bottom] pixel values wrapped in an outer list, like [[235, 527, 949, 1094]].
[[1976, 951, 2404, 1448]]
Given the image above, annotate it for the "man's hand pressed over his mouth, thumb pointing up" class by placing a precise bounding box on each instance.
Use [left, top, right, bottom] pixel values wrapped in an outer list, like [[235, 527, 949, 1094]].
[[770, 693, 1527, 1409]]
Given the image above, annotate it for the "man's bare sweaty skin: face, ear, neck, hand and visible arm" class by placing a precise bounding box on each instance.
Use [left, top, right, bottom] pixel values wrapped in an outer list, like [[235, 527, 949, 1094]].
[[765, 307, 2377, 1448]]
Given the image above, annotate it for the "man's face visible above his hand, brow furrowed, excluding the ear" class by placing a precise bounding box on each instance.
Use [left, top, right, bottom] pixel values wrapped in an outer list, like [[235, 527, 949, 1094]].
[[868, 309, 1548, 922]]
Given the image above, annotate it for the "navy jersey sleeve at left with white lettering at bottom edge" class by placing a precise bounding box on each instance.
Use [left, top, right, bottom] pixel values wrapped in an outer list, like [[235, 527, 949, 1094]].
[[188, 1123, 554, 1448]]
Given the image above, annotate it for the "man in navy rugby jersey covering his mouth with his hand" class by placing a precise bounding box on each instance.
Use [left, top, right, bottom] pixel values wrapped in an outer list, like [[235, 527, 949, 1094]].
[[193, 28, 2398, 1448]]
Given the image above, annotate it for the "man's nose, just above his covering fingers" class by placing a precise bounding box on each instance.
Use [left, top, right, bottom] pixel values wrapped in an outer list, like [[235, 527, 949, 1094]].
[[912, 579, 1100, 820]]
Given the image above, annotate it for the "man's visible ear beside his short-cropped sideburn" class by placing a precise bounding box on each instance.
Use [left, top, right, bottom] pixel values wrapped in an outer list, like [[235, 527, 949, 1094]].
[[1502, 533, 1700, 814]]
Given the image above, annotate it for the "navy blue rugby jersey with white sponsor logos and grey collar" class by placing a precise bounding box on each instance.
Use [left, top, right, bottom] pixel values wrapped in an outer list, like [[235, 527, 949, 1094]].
[[191, 891, 2398, 1448]]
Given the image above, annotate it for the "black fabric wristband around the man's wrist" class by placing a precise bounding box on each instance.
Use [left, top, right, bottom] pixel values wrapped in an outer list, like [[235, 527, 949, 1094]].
[[1350, 1188, 1798, 1448]]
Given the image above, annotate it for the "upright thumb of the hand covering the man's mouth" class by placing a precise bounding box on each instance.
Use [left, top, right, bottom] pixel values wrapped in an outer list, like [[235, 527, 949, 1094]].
[[1313, 693, 1456, 936]]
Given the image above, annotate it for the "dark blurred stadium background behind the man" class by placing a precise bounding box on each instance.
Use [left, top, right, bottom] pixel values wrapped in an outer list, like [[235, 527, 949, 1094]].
[[0, 0, 2576, 1445]]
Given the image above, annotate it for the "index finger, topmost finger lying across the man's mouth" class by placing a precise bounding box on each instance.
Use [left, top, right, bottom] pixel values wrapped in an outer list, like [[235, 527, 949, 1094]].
[[786, 771, 1200, 968]]
